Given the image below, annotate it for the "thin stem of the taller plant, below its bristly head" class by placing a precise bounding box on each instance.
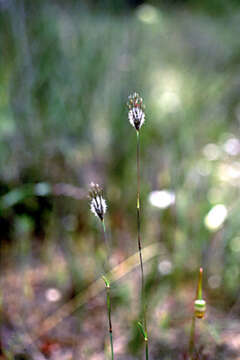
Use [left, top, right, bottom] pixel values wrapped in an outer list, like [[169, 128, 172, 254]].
[[137, 131, 148, 360]]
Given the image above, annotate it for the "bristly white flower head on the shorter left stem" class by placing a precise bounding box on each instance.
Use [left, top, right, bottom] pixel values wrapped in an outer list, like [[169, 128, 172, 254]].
[[89, 182, 107, 221]]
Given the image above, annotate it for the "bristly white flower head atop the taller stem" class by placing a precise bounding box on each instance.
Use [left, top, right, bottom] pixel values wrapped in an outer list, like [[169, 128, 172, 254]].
[[127, 92, 145, 131]]
